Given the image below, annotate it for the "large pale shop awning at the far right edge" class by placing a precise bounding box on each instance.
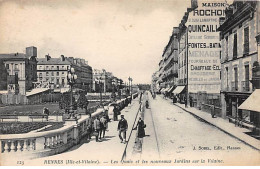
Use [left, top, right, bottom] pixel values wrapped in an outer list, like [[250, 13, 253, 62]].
[[238, 89, 260, 112]]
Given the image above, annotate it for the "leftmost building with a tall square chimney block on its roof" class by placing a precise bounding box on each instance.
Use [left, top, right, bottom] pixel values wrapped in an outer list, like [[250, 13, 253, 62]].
[[0, 46, 37, 95]]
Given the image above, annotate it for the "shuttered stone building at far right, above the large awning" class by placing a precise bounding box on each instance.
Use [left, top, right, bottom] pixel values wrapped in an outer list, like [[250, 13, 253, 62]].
[[219, 1, 260, 127]]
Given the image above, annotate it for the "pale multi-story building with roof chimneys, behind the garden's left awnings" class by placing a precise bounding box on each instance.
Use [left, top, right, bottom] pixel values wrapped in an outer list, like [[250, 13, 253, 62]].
[[37, 55, 71, 88]]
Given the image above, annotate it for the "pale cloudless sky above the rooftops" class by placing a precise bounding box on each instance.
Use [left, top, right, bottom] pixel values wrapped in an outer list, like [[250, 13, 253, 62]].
[[0, 0, 190, 84]]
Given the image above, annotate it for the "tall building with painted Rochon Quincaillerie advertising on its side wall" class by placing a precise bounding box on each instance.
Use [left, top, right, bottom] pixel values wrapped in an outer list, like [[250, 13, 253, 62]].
[[177, 0, 226, 109]]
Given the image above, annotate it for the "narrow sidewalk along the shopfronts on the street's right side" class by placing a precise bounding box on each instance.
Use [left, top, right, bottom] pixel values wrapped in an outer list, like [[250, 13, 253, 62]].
[[158, 95, 260, 150]]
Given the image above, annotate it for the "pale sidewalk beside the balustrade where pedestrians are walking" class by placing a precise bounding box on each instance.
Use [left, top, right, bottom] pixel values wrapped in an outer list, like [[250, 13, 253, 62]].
[[26, 97, 139, 165]]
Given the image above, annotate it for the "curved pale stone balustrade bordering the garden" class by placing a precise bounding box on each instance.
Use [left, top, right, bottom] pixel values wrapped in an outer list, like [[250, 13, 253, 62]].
[[0, 95, 138, 159]]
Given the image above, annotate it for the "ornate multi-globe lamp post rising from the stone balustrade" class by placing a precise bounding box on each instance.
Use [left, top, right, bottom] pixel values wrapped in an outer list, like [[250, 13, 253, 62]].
[[67, 68, 77, 118]]
